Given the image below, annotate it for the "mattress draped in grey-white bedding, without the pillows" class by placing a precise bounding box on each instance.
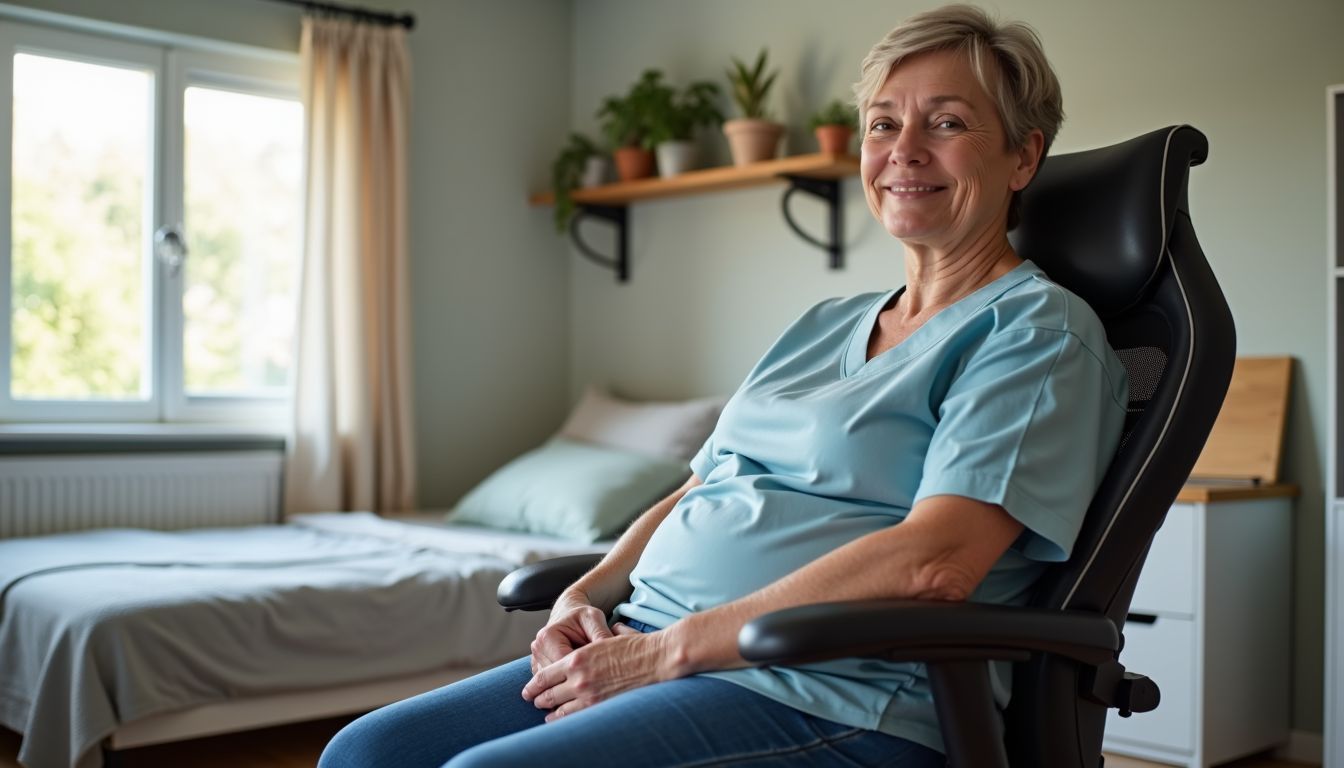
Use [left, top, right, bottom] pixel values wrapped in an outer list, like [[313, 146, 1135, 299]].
[[0, 512, 607, 768]]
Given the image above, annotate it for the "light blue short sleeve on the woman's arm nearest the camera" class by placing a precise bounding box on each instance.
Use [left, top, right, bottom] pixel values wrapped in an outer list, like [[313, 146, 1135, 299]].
[[915, 328, 1125, 561]]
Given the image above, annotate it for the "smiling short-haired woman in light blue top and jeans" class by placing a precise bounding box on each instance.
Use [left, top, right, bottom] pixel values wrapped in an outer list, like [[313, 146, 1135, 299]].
[[321, 7, 1126, 768]]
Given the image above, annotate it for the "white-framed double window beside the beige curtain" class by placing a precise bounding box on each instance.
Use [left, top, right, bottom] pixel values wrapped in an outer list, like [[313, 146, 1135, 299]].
[[0, 23, 304, 421]]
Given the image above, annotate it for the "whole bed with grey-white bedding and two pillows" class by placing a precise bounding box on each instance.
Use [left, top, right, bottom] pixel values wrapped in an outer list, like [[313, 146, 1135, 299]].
[[0, 390, 722, 768]]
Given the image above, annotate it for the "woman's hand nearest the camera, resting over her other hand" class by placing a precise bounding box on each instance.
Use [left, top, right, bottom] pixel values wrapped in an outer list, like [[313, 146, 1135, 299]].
[[523, 623, 684, 722]]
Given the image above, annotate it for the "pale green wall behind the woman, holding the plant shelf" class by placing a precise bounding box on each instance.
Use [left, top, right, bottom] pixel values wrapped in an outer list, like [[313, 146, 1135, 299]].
[[570, 0, 1344, 732]]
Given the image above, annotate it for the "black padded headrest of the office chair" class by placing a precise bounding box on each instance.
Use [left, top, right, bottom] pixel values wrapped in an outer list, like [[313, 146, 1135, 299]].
[[1009, 125, 1208, 320]]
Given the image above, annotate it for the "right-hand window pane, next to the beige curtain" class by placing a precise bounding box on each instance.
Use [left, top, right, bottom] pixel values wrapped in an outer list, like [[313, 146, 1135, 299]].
[[183, 87, 304, 395]]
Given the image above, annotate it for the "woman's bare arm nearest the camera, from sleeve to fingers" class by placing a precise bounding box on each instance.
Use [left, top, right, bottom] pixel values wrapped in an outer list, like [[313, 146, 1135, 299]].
[[523, 496, 1023, 720]]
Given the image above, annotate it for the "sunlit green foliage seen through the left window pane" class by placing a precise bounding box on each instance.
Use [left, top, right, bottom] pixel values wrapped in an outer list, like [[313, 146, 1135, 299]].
[[11, 133, 145, 399]]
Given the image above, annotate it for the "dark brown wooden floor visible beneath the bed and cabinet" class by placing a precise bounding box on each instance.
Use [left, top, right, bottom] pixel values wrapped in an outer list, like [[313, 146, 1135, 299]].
[[0, 717, 1322, 768]]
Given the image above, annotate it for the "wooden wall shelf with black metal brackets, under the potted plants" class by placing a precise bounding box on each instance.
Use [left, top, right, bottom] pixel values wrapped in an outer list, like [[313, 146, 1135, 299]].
[[528, 153, 859, 282]]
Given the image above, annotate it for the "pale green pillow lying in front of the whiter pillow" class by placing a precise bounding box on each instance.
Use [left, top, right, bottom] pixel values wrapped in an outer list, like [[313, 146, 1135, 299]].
[[448, 437, 691, 542]]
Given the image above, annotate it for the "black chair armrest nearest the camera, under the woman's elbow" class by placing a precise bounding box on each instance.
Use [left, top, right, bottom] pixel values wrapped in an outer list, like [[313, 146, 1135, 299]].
[[738, 600, 1120, 664]]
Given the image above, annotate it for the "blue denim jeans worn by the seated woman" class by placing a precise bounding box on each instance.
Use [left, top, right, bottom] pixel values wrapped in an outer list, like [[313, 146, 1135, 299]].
[[317, 658, 945, 768]]
